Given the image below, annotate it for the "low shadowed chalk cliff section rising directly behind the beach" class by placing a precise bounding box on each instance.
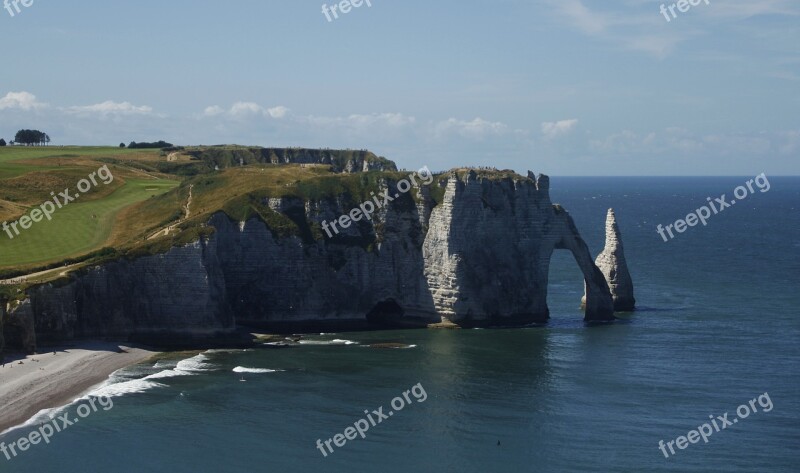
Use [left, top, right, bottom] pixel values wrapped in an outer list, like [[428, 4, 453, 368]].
[[6, 241, 234, 345]]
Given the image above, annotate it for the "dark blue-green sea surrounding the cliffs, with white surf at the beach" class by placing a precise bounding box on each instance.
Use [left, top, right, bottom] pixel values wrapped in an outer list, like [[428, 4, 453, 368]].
[[0, 175, 800, 473]]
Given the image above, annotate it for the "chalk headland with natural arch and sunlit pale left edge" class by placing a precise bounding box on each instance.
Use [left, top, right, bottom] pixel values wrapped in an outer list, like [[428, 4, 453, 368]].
[[423, 172, 613, 325]]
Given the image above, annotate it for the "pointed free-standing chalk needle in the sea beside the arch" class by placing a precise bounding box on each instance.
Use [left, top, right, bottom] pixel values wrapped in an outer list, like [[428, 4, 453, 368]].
[[584, 209, 636, 312]]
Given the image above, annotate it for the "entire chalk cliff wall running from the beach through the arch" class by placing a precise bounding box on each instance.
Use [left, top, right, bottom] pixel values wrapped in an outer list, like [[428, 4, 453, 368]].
[[3, 171, 629, 341]]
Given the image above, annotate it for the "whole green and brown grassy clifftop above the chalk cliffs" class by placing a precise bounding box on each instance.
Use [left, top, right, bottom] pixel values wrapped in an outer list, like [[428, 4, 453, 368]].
[[0, 146, 521, 287]]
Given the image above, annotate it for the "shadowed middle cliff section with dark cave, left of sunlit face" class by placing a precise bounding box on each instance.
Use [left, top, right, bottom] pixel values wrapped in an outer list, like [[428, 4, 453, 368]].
[[209, 181, 440, 332]]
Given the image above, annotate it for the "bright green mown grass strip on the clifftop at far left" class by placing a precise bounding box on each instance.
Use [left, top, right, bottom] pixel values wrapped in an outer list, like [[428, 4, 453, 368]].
[[0, 178, 179, 268]]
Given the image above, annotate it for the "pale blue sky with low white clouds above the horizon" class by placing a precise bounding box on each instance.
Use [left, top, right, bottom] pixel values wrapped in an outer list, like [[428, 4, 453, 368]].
[[0, 0, 800, 176]]
